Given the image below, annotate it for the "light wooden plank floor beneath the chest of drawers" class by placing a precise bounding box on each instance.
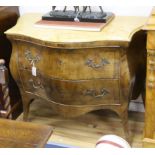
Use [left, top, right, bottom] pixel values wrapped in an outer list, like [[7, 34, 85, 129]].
[[18, 101, 144, 148]]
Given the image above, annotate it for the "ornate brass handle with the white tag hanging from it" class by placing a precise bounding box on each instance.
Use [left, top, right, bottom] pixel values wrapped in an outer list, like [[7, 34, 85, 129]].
[[25, 51, 40, 64]]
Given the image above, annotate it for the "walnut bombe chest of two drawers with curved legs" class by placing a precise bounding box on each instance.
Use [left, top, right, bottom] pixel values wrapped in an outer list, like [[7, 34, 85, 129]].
[[6, 14, 146, 141]]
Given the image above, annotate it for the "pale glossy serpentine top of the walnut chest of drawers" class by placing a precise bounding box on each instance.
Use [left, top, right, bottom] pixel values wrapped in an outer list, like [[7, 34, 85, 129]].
[[5, 13, 147, 49]]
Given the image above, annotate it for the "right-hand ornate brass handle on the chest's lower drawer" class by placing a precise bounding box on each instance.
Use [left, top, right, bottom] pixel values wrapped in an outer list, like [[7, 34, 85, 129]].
[[84, 88, 109, 98]]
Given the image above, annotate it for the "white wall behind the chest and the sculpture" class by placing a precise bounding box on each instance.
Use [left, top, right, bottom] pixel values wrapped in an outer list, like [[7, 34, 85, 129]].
[[19, 6, 152, 16]]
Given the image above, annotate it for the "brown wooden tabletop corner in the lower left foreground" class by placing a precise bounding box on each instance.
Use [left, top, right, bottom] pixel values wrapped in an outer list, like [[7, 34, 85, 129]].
[[0, 119, 52, 148]]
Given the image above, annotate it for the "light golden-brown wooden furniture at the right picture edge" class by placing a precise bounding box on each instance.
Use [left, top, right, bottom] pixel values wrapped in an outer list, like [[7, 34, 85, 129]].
[[143, 7, 155, 148]]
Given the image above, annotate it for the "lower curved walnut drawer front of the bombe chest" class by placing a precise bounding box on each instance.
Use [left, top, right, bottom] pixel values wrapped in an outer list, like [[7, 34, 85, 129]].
[[20, 70, 119, 105]]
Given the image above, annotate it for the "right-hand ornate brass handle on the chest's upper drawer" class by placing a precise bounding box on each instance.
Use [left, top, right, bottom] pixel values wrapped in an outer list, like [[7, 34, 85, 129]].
[[85, 58, 110, 69]]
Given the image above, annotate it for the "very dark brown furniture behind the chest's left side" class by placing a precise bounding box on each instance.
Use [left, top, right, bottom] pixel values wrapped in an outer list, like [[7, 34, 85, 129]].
[[0, 6, 22, 119]]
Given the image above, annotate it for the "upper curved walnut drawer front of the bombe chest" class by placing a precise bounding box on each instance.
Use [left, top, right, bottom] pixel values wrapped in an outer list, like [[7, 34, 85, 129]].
[[18, 42, 120, 80]]
